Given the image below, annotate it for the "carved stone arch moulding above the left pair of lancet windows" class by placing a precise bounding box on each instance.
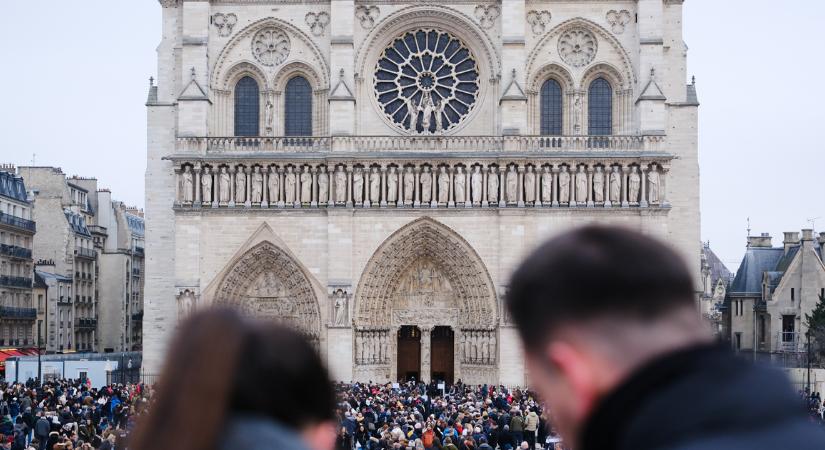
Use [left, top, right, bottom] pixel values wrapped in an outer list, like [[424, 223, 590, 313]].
[[210, 17, 329, 89]]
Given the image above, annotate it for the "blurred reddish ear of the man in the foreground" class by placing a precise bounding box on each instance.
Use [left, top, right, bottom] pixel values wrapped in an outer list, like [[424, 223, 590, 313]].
[[546, 341, 600, 421]]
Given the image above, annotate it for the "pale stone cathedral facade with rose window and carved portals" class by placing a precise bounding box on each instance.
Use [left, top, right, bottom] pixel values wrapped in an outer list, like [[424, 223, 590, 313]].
[[143, 0, 702, 384]]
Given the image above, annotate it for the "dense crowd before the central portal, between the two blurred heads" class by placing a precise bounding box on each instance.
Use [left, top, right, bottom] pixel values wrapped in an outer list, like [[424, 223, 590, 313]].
[[336, 382, 562, 450]]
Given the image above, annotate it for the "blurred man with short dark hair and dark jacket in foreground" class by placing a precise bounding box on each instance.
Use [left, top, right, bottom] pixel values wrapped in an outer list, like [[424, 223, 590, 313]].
[[507, 226, 825, 450]]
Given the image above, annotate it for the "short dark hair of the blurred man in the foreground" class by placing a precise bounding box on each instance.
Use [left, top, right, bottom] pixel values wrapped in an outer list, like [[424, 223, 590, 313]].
[[507, 225, 698, 351]]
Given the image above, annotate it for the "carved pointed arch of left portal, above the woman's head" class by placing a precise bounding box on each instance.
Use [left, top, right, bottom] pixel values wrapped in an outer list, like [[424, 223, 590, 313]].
[[214, 242, 321, 342]]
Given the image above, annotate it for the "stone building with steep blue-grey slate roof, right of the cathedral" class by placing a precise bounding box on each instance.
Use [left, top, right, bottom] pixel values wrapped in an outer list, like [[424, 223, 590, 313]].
[[724, 229, 825, 359]]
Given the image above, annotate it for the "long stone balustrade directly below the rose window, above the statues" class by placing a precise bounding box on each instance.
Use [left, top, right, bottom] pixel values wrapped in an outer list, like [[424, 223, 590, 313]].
[[176, 135, 665, 155]]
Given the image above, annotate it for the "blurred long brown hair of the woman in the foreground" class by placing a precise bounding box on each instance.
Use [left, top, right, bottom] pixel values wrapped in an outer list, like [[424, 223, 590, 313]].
[[129, 308, 335, 450]]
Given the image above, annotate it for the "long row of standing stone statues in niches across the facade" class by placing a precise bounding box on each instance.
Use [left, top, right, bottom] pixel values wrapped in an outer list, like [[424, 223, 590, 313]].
[[175, 155, 670, 209]]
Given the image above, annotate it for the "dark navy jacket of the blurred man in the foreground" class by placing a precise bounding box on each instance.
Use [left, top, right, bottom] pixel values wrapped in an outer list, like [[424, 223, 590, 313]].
[[580, 345, 825, 450]]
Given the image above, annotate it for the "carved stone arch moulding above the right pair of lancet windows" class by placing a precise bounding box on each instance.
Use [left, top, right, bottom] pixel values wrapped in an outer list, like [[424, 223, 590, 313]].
[[527, 18, 636, 88]]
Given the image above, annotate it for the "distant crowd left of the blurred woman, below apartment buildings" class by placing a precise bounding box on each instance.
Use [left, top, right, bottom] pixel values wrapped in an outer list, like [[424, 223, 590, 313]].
[[0, 380, 151, 450]]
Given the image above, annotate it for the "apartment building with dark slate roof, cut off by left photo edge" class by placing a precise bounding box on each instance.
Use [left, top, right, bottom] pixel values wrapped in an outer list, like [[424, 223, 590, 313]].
[[0, 165, 37, 347]]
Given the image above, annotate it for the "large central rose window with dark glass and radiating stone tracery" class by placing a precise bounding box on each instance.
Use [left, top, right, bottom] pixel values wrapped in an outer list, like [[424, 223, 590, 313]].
[[375, 30, 479, 134]]
